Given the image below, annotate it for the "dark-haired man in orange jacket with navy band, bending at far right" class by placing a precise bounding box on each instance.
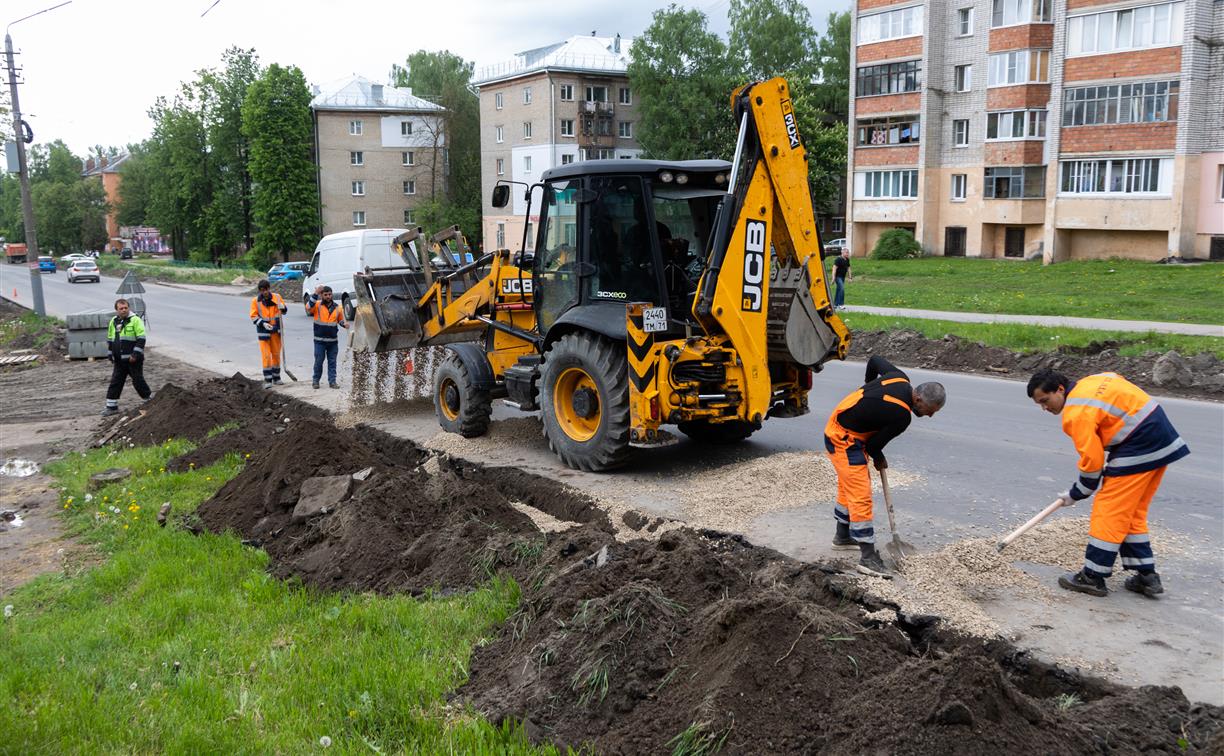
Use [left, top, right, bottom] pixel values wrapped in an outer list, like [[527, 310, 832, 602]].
[[1028, 368, 1190, 598]]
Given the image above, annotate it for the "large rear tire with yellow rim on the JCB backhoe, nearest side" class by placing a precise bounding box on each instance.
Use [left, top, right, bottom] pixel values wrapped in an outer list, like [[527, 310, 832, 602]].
[[540, 333, 632, 472]]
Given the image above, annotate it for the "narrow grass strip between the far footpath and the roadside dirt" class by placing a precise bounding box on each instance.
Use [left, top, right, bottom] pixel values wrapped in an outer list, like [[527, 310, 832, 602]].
[[840, 312, 1224, 360]]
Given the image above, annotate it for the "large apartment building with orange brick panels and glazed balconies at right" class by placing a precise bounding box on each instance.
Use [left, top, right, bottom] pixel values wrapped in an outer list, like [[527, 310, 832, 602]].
[[847, 0, 1224, 262]]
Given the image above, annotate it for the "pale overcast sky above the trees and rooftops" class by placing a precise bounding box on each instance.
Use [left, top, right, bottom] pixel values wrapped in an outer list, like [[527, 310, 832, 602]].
[[0, 0, 849, 155]]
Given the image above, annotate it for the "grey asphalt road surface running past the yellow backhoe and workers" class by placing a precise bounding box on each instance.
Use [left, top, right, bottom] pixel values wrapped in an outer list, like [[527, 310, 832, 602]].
[[0, 265, 1224, 703]]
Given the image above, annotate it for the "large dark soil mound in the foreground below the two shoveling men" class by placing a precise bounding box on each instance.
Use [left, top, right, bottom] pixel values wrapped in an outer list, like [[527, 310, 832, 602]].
[[461, 531, 1224, 754]]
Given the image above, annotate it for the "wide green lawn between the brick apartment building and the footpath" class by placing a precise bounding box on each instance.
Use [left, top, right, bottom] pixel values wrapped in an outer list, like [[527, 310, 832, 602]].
[[826, 257, 1224, 324]]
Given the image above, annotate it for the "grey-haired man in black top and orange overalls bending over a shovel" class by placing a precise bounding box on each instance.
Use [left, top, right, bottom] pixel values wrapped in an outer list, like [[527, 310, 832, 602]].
[[825, 355, 947, 576]]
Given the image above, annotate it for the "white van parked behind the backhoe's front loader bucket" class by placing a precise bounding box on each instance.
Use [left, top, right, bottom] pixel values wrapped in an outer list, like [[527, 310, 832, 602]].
[[302, 229, 416, 318]]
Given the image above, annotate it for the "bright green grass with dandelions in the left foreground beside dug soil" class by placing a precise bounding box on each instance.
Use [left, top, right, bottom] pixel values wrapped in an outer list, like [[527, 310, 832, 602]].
[[0, 442, 553, 754]]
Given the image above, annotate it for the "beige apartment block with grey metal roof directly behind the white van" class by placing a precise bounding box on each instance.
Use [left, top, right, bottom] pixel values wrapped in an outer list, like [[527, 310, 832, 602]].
[[311, 76, 448, 235]]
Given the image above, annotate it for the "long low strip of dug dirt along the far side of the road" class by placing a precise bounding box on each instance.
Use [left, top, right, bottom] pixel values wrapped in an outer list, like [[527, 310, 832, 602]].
[[849, 329, 1224, 400]]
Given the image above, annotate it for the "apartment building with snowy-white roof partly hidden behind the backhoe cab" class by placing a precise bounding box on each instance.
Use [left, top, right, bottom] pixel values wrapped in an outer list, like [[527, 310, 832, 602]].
[[472, 34, 641, 250]]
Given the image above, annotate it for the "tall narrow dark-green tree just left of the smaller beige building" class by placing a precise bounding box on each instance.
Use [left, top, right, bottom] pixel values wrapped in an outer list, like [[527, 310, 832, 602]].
[[242, 64, 319, 268]]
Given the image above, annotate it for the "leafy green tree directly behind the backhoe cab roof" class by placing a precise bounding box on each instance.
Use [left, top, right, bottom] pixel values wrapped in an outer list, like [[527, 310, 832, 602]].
[[628, 4, 737, 160]]
